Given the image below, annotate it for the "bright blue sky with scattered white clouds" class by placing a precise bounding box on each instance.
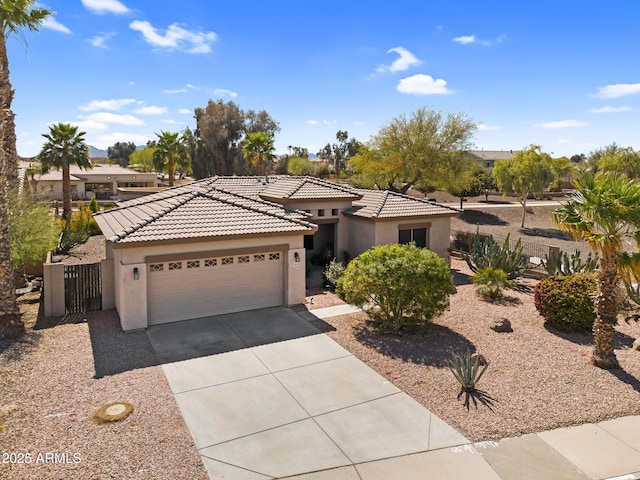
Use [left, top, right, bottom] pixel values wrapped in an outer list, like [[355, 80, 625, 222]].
[[8, 0, 640, 156]]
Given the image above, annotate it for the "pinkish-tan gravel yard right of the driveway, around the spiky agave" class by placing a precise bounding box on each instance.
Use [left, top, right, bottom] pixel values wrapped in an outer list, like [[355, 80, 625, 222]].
[[325, 259, 640, 441]]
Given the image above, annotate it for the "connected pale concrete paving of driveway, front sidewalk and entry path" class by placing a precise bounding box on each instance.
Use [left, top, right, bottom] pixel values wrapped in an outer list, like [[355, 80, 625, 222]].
[[147, 307, 640, 480]]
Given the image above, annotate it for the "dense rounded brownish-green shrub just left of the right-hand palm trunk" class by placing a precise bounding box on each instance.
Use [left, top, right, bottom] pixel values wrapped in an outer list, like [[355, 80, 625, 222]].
[[533, 273, 598, 332]]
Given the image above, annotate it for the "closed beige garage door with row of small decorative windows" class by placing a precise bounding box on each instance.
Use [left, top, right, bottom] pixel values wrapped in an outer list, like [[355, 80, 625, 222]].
[[147, 251, 284, 325]]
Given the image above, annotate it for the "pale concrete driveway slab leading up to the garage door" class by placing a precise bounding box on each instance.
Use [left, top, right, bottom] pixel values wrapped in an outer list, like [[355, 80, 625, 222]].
[[147, 308, 480, 480]]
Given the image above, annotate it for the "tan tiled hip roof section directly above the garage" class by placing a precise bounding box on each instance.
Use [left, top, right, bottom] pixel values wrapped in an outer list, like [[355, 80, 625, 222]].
[[94, 179, 317, 248]]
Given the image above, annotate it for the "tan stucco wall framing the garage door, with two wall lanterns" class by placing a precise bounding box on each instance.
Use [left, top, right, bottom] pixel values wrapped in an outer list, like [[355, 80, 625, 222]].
[[107, 234, 305, 331]]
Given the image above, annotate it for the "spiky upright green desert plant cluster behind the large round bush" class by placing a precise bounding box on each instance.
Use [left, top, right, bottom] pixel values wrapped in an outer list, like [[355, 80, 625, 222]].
[[464, 233, 526, 280]]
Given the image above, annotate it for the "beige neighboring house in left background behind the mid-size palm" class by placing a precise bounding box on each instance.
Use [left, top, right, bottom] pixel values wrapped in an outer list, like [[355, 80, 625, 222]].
[[29, 164, 158, 200]]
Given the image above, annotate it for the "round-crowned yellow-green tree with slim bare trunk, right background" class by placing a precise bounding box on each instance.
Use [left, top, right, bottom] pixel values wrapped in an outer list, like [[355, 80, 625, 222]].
[[493, 145, 555, 228]]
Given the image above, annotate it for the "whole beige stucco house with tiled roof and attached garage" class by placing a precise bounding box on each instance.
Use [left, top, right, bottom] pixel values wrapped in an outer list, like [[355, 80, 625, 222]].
[[95, 176, 459, 330]]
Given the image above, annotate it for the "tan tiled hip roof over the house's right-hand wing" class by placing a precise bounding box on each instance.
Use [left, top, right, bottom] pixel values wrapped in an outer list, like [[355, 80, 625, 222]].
[[344, 189, 460, 219]]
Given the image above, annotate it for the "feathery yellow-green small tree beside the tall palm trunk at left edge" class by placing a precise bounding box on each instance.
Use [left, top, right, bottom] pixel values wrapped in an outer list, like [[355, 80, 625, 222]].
[[9, 189, 62, 269]]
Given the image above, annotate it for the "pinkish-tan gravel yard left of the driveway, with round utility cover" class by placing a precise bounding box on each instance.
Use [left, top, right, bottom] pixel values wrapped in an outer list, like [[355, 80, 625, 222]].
[[0, 294, 209, 480]]
